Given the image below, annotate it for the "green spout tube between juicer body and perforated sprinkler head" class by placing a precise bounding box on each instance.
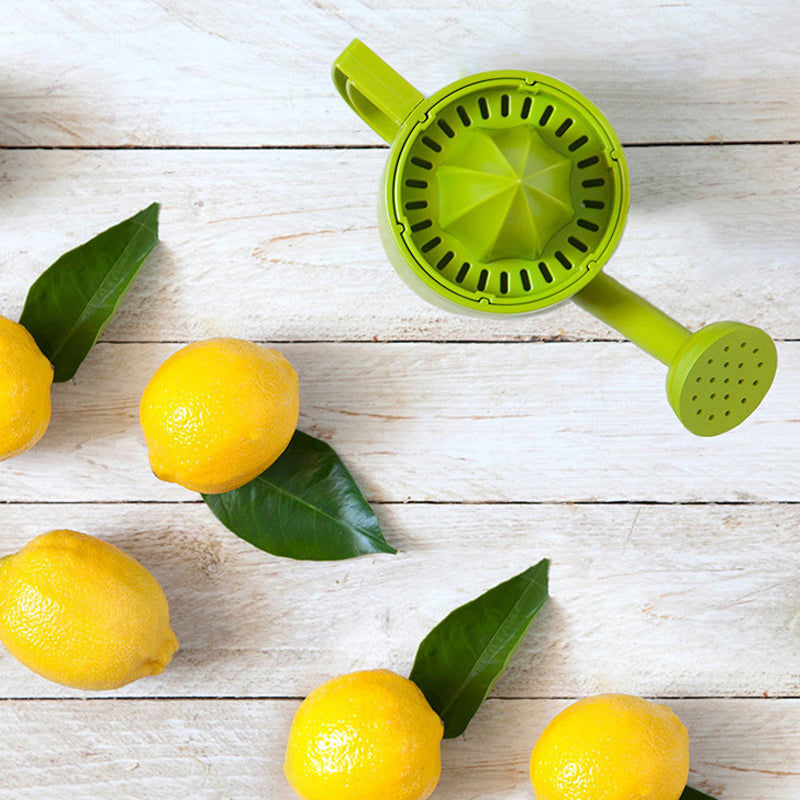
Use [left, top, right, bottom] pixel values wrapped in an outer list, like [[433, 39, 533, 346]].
[[572, 272, 692, 366]]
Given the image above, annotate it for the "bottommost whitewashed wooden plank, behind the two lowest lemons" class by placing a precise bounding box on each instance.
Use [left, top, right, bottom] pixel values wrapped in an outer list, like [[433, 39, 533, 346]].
[[0, 700, 800, 800]]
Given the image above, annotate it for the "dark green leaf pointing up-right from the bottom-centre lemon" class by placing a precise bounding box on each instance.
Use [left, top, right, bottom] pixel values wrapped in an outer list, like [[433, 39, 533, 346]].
[[409, 559, 550, 739]]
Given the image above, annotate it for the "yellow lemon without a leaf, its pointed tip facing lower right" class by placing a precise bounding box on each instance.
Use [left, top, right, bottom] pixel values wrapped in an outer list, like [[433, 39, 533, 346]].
[[0, 530, 178, 690]]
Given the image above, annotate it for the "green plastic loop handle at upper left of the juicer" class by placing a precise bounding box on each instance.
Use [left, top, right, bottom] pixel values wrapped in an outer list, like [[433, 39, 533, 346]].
[[333, 39, 425, 144]]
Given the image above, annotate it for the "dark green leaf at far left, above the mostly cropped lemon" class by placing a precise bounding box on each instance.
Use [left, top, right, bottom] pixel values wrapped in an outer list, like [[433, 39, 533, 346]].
[[19, 203, 159, 381]]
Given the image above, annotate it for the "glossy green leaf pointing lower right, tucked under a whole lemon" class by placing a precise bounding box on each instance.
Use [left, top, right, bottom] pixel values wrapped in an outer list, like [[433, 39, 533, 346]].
[[203, 431, 397, 561]]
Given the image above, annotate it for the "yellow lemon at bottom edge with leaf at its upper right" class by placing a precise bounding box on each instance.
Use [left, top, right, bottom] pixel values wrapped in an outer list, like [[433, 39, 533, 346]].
[[284, 669, 444, 800]]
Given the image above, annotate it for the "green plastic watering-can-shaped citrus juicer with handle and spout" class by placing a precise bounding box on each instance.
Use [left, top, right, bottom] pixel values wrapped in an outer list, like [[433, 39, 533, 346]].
[[333, 39, 777, 436]]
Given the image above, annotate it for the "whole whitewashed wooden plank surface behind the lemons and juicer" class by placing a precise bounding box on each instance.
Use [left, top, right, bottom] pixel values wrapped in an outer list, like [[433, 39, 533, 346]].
[[0, 0, 800, 800]]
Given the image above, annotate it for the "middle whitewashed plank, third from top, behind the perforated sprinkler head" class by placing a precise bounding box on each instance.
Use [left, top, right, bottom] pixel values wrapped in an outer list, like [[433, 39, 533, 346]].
[[0, 342, 800, 502]]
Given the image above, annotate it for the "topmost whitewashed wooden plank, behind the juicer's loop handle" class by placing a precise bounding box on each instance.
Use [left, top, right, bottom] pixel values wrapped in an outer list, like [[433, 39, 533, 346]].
[[0, 0, 800, 146]]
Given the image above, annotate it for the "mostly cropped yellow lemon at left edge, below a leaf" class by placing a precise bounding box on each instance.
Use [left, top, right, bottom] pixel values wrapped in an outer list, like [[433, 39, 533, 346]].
[[0, 317, 53, 461]]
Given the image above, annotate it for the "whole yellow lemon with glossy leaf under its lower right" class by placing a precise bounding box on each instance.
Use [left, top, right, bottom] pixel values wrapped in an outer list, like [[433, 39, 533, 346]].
[[139, 339, 299, 494]]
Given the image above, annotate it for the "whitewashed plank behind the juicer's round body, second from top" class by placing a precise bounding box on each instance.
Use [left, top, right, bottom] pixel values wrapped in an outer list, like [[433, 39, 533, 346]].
[[0, 146, 800, 341]]
